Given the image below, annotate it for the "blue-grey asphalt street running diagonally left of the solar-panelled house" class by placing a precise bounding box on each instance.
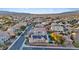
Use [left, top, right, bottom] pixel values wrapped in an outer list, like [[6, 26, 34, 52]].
[[8, 25, 32, 50]]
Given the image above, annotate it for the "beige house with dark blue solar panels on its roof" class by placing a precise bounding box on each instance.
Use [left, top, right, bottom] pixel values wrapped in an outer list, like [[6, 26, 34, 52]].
[[29, 28, 48, 45]]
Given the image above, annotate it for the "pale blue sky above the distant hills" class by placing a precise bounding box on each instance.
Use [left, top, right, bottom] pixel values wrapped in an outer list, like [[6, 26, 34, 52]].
[[0, 8, 79, 14]]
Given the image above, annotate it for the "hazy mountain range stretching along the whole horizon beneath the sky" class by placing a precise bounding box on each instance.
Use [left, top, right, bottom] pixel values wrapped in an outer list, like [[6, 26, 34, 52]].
[[0, 10, 79, 15]]
